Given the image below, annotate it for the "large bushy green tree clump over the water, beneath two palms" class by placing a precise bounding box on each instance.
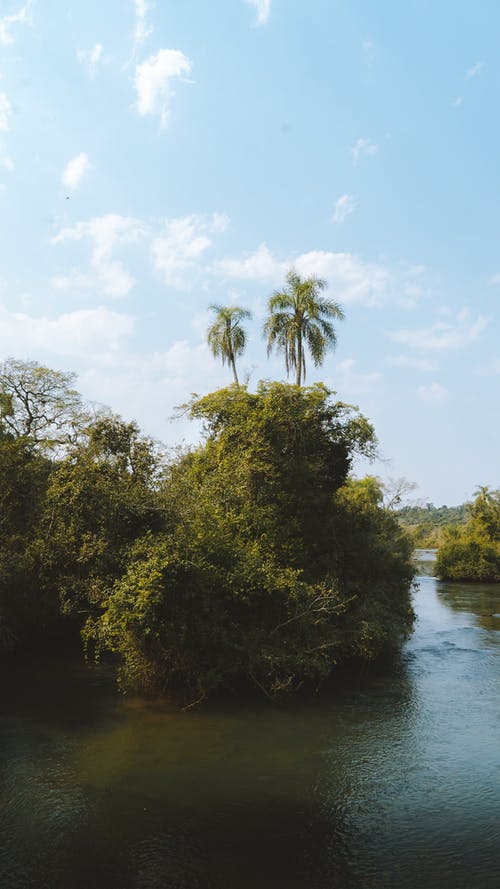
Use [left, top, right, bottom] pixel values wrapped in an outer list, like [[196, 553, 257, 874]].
[[85, 383, 412, 700]]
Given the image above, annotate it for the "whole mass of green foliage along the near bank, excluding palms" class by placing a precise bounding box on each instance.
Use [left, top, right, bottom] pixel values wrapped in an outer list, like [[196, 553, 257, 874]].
[[0, 363, 413, 700]]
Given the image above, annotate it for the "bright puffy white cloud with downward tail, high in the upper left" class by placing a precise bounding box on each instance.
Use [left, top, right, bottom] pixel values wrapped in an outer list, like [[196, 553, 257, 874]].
[[135, 49, 192, 128]]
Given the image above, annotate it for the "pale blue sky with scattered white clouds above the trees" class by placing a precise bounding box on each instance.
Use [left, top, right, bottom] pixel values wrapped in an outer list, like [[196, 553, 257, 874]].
[[0, 0, 500, 505]]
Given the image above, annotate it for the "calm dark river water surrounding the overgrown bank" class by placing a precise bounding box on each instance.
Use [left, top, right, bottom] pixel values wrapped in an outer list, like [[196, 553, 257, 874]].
[[0, 553, 500, 889]]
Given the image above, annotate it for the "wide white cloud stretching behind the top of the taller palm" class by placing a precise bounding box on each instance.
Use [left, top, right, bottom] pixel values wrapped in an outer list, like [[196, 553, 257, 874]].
[[214, 244, 391, 305]]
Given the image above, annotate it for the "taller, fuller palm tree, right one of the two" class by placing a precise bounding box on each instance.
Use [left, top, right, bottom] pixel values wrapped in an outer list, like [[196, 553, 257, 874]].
[[264, 269, 344, 386]]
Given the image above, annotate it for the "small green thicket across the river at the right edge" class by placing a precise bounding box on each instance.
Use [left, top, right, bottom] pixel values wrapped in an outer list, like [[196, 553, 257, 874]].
[[436, 487, 500, 583]]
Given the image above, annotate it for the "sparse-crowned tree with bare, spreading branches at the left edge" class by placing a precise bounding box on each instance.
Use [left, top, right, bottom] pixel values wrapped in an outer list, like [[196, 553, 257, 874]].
[[0, 358, 90, 450]]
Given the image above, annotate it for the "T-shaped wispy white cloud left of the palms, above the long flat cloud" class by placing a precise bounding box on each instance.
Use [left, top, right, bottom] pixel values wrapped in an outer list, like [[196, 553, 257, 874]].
[[52, 213, 146, 297]]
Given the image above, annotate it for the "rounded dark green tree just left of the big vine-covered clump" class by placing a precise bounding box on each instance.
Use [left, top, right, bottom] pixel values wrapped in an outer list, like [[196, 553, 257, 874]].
[[38, 417, 163, 614]]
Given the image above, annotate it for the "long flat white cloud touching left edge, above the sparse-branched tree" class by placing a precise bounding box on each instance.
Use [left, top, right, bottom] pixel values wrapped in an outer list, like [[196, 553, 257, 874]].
[[0, 306, 134, 357]]
